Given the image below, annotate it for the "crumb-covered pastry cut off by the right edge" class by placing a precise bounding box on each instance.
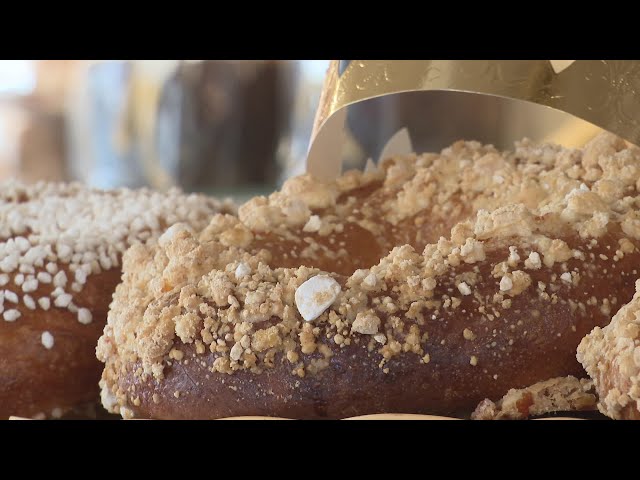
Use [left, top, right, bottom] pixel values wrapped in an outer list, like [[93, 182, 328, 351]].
[[577, 280, 640, 420]]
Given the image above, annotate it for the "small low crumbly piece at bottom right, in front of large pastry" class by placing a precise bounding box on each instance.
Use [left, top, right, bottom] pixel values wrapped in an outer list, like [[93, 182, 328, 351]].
[[471, 376, 596, 420]]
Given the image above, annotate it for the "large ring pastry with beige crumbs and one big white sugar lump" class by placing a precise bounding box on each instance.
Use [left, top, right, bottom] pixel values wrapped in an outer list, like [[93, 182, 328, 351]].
[[97, 135, 640, 418]]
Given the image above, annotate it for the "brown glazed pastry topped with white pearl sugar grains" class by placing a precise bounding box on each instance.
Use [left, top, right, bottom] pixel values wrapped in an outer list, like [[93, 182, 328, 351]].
[[0, 182, 231, 418]]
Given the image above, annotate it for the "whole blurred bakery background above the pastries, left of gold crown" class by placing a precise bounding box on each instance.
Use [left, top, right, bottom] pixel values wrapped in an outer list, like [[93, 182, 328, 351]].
[[0, 60, 329, 200]]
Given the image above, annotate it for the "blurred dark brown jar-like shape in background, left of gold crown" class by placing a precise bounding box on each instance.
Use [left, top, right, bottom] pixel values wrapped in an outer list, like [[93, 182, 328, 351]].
[[156, 61, 295, 195]]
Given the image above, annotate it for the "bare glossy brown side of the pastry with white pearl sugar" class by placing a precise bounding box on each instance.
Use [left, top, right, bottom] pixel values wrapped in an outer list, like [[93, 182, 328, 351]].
[[0, 269, 120, 419]]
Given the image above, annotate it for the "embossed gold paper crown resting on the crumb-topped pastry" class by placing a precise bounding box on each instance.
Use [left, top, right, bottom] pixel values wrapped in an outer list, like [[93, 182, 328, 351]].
[[307, 60, 640, 179]]
